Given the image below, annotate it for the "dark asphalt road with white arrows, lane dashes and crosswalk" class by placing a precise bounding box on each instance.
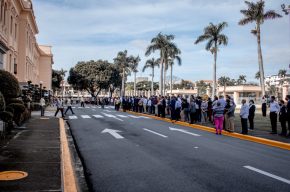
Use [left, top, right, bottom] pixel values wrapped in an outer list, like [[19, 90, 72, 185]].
[[68, 106, 290, 192]]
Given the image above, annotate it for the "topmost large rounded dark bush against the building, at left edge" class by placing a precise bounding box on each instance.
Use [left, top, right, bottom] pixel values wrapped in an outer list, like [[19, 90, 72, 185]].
[[0, 70, 21, 99]]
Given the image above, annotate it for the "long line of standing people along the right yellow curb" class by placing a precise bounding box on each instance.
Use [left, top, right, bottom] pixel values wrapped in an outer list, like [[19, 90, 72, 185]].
[[111, 95, 290, 137]]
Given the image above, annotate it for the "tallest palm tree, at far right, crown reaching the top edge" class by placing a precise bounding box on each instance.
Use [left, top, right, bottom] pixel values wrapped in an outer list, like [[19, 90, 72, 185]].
[[239, 0, 282, 95]]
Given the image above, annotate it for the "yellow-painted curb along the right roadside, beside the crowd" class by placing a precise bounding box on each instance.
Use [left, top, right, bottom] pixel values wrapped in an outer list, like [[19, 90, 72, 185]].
[[127, 111, 290, 151]]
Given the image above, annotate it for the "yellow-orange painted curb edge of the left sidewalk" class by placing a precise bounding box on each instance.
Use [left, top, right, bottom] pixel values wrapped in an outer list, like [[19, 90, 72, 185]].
[[59, 118, 78, 192]]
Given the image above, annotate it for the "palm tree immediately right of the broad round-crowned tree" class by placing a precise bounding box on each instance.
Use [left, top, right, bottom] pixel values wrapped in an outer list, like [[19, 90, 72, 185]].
[[114, 50, 130, 97]]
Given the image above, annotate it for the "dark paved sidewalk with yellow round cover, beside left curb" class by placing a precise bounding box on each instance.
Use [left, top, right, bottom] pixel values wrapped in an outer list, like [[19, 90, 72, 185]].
[[0, 111, 62, 192]]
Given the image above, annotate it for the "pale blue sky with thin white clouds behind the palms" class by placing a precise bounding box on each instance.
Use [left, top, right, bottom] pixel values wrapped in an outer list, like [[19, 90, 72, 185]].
[[33, 0, 290, 81]]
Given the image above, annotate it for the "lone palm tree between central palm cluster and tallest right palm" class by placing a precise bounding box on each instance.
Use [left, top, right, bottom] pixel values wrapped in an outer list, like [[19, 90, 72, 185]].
[[194, 22, 228, 97]]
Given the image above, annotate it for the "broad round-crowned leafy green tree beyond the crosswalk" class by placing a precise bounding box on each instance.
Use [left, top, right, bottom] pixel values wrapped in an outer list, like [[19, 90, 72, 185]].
[[68, 60, 121, 97]]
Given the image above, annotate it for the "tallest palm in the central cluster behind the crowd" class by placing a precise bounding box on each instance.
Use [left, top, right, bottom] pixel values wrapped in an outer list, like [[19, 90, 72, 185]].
[[145, 33, 178, 95]]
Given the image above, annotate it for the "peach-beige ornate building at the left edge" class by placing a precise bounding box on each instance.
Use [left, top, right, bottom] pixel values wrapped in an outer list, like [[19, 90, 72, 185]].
[[0, 0, 53, 90]]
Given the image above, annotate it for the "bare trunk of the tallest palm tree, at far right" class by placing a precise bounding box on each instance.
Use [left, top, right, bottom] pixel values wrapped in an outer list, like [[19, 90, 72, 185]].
[[257, 24, 265, 96]]
